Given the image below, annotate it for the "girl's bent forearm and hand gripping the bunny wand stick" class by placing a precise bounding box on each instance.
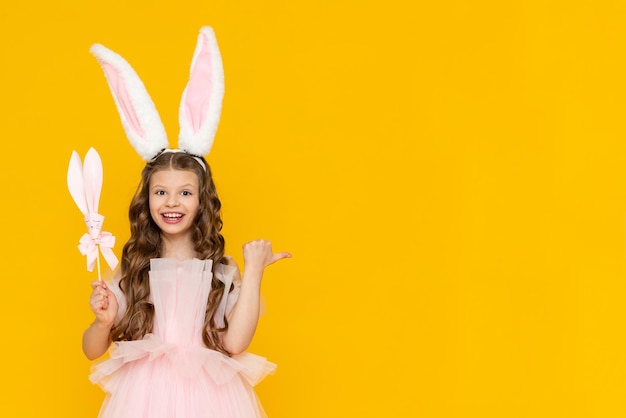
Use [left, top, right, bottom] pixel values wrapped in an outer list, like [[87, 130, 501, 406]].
[[83, 281, 118, 360]]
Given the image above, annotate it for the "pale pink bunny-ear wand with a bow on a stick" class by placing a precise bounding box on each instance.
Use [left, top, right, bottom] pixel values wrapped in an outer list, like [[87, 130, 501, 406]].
[[67, 148, 118, 280]]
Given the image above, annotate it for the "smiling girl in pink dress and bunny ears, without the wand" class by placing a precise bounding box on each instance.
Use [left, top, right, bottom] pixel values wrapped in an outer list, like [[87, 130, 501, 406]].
[[83, 28, 291, 418]]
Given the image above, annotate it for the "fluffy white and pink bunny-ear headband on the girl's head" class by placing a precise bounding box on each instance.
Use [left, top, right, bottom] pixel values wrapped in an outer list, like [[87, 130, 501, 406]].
[[91, 26, 224, 170]]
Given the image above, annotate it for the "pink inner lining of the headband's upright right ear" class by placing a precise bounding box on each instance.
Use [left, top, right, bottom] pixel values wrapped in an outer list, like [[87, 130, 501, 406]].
[[185, 36, 213, 134]]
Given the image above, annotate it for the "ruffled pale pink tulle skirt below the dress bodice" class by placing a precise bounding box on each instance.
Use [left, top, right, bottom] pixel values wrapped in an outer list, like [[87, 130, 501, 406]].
[[90, 334, 276, 418]]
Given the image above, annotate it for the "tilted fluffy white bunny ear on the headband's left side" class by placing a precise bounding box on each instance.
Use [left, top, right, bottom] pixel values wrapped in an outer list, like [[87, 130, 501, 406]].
[[90, 44, 168, 161]]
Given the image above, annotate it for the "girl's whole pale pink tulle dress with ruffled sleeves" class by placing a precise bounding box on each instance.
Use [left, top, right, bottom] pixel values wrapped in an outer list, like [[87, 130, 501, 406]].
[[90, 258, 276, 418]]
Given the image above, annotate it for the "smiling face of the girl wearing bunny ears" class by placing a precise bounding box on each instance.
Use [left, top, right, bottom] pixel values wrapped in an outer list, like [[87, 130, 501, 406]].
[[149, 170, 200, 238]]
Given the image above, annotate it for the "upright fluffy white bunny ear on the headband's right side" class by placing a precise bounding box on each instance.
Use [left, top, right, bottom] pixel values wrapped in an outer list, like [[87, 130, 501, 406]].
[[178, 26, 224, 156]]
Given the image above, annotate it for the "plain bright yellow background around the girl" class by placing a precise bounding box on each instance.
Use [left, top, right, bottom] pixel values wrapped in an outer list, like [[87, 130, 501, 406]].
[[0, 0, 626, 418]]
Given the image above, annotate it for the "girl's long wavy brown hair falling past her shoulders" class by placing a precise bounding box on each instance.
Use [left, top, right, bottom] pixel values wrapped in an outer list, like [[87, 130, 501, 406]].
[[111, 152, 232, 355]]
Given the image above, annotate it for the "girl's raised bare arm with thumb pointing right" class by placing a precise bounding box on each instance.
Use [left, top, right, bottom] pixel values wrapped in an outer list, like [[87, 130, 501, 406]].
[[222, 240, 291, 354]]
